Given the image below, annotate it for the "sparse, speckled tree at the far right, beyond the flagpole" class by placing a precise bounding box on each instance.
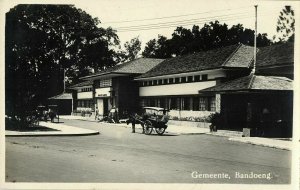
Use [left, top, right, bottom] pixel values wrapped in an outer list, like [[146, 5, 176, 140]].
[[274, 6, 295, 42]]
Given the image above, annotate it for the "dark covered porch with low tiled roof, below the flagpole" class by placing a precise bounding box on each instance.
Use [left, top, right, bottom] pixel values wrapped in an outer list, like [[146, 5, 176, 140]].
[[199, 74, 293, 137]]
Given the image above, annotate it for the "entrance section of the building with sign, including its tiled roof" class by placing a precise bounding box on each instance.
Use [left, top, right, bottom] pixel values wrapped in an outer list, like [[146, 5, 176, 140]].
[[78, 58, 163, 117]]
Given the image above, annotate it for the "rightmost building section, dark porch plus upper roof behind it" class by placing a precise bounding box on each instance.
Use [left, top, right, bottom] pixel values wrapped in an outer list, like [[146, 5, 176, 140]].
[[199, 42, 294, 138]]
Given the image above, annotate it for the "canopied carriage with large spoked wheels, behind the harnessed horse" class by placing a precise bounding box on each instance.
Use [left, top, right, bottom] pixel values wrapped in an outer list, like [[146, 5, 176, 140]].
[[141, 107, 169, 135]]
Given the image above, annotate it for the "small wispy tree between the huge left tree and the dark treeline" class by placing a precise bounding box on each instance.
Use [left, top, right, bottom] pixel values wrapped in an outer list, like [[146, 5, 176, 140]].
[[117, 37, 142, 62]]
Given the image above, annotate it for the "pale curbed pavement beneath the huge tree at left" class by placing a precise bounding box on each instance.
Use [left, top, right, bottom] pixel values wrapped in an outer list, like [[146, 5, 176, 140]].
[[5, 122, 100, 136]]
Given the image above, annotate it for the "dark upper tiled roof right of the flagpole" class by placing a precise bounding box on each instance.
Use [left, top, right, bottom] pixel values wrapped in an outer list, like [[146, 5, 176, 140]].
[[256, 42, 294, 67]]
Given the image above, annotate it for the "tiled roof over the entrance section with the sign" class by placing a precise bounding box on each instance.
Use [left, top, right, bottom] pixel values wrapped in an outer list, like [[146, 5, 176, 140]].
[[82, 58, 163, 78]]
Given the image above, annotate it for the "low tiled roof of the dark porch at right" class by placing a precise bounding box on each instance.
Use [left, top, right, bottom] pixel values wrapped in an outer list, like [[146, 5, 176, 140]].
[[199, 74, 293, 93]]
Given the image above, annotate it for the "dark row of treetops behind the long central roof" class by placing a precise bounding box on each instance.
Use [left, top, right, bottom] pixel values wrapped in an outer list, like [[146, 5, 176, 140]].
[[142, 21, 271, 58]]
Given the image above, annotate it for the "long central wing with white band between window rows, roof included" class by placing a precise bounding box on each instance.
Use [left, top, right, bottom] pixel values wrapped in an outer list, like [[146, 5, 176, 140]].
[[136, 44, 254, 121]]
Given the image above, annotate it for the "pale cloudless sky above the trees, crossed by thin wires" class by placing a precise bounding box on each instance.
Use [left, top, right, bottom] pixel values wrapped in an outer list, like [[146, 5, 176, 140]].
[[4, 0, 299, 48]]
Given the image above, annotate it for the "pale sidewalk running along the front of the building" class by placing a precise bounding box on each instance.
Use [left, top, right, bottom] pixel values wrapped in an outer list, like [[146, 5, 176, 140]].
[[61, 116, 293, 150]]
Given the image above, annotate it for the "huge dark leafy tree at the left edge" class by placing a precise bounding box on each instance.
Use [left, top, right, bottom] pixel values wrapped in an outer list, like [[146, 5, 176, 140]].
[[5, 5, 119, 121]]
